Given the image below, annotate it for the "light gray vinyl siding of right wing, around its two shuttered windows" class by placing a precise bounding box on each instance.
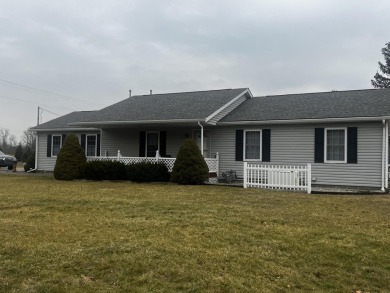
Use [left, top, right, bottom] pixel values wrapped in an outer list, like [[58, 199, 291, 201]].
[[212, 123, 382, 187]]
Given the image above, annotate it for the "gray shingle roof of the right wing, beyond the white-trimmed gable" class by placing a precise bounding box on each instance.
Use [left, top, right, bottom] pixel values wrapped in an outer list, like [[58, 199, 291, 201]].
[[220, 89, 390, 122]]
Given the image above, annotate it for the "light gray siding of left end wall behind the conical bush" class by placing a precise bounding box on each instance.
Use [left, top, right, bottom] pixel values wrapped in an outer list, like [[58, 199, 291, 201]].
[[37, 131, 99, 172]]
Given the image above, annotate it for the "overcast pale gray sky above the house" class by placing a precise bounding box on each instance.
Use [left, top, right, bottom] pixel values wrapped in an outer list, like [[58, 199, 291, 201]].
[[0, 0, 390, 138]]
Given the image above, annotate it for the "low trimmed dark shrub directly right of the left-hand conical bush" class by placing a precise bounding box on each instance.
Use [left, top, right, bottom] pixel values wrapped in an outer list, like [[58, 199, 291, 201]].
[[85, 161, 127, 180]]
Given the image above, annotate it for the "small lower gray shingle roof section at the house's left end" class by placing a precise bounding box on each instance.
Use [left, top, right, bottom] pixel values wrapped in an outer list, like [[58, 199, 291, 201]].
[[30, 111, 96, 130]]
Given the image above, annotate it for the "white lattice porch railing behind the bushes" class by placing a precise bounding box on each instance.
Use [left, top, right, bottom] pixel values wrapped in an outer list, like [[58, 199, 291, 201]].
[[87, 151, 219, 176]]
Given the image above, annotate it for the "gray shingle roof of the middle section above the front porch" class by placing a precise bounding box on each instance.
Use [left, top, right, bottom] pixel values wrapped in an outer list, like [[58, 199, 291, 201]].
[[94, 88, 246, 122]]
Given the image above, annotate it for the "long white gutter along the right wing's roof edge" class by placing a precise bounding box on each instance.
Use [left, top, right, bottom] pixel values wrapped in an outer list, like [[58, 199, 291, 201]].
[[217, 116, 390, 126]]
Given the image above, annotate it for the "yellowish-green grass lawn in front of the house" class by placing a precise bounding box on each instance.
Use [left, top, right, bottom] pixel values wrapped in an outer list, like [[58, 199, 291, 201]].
[[0, 174, 390, 292]]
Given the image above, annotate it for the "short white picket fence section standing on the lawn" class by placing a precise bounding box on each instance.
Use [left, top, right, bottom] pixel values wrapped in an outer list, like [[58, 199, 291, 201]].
[[244, 162, 311, 193]]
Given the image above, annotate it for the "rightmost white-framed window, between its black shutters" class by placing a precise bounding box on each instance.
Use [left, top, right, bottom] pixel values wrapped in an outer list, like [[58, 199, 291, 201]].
[[325, 128, 347, 163]]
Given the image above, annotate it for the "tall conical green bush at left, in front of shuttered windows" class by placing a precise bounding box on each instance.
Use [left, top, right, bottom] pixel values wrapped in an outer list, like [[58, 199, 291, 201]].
[[54, 134, 87, 180]]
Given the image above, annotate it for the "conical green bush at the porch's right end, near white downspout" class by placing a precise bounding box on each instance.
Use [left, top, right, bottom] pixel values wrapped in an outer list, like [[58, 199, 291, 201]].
[[171, 139, 209, 185]]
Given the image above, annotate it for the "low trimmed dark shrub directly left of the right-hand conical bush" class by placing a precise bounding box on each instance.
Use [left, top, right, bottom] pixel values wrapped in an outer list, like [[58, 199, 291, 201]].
[[126, 162, 170, 182]]
